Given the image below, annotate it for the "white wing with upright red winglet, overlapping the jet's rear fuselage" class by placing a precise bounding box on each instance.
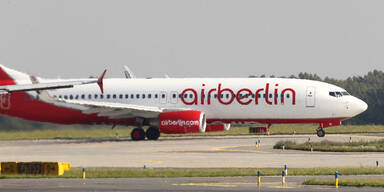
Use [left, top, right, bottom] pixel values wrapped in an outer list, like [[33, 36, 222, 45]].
[[0, 70, 106, 94]]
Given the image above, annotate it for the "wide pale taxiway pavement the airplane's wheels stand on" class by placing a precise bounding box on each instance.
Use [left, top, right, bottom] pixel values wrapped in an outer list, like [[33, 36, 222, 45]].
[[0, 135, 384, 168]]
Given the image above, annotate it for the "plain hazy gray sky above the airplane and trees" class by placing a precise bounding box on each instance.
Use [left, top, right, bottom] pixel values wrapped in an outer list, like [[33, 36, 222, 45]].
[[0, 0, 384, 79]]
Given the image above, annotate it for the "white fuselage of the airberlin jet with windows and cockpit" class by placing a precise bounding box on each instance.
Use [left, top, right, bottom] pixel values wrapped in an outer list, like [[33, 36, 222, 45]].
[[44, 78, 367, 122]]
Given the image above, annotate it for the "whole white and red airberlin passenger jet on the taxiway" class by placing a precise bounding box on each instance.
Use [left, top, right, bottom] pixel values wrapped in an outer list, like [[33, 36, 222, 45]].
[[0, 65, 368, 141]]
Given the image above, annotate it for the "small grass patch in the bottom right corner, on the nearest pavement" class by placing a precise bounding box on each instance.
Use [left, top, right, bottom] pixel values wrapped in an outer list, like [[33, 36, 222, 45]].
[[303, 178, 384, 187]]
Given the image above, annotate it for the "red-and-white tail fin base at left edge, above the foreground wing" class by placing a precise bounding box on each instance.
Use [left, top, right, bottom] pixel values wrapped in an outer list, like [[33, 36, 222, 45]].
[[0, 64, 30, 86]]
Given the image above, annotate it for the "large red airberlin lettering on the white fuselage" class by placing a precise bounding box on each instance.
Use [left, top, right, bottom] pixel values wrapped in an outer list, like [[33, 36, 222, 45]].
[[181, 83, 296, 105]]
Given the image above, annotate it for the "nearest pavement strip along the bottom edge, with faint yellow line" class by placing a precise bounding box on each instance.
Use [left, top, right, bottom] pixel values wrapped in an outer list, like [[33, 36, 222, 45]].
[[0, 176, 383, 192]]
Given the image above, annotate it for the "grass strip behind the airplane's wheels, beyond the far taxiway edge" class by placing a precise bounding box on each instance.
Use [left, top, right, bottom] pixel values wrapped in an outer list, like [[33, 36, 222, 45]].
[[0, 125, 384, 140]]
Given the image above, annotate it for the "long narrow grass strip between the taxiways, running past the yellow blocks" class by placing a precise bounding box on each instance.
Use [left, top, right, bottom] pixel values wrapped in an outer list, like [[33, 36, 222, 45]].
[[0, 167, 384, 179]]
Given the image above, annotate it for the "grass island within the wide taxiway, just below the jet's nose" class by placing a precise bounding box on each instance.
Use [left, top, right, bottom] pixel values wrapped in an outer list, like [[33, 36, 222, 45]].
[[273, 140, 384, 152]]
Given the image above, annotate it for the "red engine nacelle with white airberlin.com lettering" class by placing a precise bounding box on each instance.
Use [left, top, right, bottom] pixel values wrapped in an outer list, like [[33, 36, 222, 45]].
[[159, 110, 207, 134]]
